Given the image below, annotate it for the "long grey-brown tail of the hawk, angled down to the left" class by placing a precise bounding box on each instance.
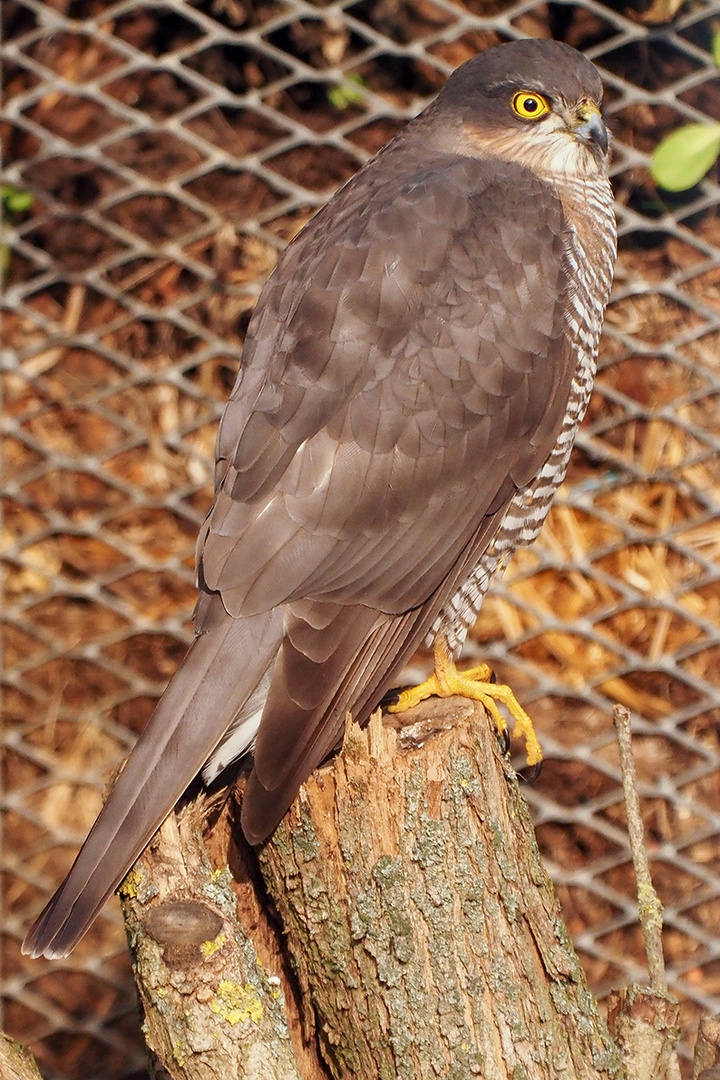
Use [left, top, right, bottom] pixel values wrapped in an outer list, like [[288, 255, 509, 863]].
[[23, 611, 283, 959]]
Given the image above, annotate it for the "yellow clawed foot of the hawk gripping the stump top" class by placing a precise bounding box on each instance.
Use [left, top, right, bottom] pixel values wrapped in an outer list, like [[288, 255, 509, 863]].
[[388, 644, 543, 766]]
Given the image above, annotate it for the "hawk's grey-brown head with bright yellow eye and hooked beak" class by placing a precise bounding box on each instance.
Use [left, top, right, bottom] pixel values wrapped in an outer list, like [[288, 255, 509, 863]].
[[436, 39, 610, 178]]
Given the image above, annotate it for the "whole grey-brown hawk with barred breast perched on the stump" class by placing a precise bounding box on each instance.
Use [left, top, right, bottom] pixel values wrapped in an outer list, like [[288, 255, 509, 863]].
[[25, 40, 615, 957]]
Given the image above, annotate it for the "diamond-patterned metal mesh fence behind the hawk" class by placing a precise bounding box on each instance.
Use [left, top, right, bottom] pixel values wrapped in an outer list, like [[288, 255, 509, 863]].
[[0, 0, 720, 1080]]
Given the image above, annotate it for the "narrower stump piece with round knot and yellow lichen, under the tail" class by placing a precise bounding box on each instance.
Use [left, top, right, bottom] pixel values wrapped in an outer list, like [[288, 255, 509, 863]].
[[120, 804, 304, 1080]]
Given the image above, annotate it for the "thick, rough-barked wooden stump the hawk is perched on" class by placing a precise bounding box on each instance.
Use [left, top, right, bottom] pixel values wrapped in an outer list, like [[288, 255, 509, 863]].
[[260, 699, 622, 1080]]
